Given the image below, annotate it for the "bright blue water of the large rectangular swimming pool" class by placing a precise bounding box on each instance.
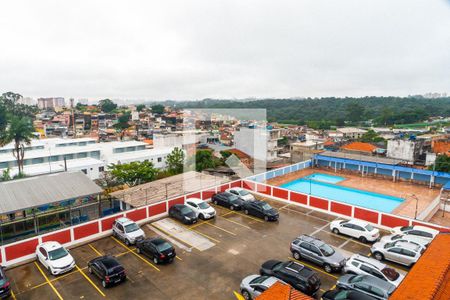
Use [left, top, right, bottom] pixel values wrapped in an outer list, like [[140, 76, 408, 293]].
[[281, 173, 404, 213]]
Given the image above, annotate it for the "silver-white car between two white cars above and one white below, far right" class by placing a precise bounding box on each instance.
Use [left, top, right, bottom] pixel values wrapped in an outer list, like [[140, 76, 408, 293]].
[[370, 241, 424, 267]]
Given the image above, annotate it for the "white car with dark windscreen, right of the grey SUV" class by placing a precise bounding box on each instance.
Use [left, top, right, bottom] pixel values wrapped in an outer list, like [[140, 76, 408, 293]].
[[344, 254, 405, 286]]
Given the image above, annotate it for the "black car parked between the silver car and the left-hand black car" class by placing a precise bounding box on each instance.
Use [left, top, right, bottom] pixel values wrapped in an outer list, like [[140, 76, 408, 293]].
[[136, 238, 177, 264]]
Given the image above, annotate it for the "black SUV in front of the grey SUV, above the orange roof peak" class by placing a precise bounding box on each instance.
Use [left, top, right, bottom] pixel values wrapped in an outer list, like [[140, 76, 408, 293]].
[[259, 260, 320, 296]]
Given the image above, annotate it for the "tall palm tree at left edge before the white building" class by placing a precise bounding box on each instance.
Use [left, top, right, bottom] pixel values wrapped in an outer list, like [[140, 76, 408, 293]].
[[0, 115, 35, 176]]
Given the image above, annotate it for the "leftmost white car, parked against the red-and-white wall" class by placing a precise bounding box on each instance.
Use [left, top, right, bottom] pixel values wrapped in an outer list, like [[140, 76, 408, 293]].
[[36, 242, 75, 275]]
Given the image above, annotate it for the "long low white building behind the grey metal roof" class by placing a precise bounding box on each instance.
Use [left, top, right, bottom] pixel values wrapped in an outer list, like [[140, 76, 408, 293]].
[[0, 138, 172, 179]]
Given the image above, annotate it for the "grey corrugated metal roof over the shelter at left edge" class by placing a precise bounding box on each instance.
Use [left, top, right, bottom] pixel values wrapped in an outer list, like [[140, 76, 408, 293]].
[[0, 171, 102, 214]]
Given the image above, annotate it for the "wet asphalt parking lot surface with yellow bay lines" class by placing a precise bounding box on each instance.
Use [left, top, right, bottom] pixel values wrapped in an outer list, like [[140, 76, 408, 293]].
[[7, 196, 407, 300]]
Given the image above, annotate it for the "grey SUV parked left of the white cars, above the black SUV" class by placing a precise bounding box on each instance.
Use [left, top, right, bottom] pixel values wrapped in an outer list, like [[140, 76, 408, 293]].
[[291, 235, 345, 273]]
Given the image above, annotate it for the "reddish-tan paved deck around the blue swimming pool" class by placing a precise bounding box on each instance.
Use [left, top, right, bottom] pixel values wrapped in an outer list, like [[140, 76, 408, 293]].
[[267, 168, 439, 218]]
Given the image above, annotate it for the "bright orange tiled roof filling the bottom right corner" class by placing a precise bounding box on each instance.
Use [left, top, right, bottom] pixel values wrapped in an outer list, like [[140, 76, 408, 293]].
[[389, 233, 450, 300]]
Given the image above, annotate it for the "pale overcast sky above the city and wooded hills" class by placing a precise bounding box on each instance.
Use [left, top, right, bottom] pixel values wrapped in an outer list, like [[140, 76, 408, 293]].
[[0, 0, 450, 100]]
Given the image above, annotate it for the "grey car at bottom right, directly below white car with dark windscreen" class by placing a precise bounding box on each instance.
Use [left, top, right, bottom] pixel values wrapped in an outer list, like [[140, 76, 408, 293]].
[[336, 274, 395, 299]]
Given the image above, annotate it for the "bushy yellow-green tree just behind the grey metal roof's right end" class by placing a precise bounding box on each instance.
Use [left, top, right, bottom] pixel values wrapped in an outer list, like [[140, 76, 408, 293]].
[[108, 160, 158, 186]]
